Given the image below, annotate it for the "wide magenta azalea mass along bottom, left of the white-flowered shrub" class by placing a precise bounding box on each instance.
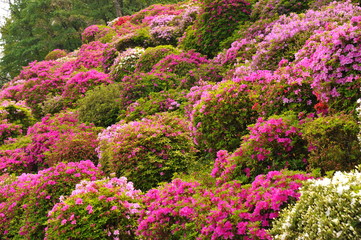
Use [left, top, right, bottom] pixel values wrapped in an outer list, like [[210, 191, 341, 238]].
[[137, 171, 309, 239]]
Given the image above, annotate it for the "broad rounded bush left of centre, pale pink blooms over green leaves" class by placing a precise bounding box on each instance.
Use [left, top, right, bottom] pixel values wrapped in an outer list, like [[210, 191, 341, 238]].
[[98, 114, 196, 190]]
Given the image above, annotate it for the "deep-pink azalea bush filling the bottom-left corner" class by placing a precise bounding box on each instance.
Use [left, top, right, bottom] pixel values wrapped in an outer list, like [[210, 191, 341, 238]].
[[0, 161, 104, 239]]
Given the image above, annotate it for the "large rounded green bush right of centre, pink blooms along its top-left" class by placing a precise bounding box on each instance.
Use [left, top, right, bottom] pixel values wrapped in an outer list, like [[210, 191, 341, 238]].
[[190, 81, 255, 153]]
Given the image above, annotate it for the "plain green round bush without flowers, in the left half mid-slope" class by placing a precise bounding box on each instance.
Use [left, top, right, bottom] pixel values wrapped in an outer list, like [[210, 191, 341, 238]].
[[77, 83, 121, 127]]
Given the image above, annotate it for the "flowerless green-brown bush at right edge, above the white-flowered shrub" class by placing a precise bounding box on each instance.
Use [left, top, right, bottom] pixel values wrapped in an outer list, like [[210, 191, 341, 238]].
[[302, 113, 361, 173]]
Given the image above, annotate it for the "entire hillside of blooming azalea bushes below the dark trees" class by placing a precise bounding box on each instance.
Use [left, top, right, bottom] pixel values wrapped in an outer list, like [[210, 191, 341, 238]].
[[0, 0, 361, 240]]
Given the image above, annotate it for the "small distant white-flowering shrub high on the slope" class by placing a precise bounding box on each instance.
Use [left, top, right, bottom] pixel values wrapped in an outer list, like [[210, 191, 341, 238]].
[[110, 47, 145, 81]]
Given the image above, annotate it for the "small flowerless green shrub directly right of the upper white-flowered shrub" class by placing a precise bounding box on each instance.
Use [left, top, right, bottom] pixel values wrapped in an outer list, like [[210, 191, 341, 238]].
[[136, 45, 179, 72]]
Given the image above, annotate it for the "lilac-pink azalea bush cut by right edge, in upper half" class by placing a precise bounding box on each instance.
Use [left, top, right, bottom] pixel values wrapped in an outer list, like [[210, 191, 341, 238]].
[[295, 14, 361, 112]]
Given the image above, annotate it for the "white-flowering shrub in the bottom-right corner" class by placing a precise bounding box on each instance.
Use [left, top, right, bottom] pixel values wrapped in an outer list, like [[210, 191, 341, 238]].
[[270, 166, 361, 240]]
